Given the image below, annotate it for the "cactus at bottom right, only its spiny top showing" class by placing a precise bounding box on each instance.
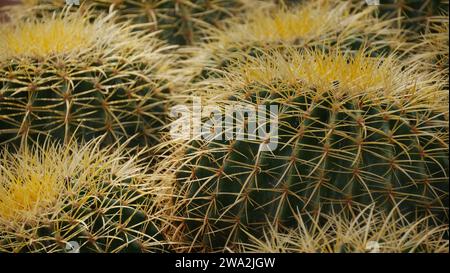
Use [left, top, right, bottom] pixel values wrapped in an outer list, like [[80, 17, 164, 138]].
[[239, 206, 449, 253]]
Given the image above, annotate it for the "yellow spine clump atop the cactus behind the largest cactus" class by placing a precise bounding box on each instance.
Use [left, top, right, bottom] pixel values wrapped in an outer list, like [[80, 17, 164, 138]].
[[210, 0, 385, 46]]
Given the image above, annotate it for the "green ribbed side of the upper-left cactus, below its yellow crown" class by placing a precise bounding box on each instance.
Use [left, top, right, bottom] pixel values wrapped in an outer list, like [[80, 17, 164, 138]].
[[0, 56, 164, 146]]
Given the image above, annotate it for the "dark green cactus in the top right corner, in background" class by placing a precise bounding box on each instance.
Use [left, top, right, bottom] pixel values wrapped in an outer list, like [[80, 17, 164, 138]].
[[379, 0, 448, 31]]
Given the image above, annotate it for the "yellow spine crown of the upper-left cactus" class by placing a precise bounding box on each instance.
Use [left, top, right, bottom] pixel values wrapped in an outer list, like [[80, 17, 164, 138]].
[[0, 12, 170, 61]]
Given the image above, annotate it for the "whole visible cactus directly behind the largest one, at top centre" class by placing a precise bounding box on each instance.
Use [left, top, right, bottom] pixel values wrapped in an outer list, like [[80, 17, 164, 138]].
[[186, 0, 401, 81]]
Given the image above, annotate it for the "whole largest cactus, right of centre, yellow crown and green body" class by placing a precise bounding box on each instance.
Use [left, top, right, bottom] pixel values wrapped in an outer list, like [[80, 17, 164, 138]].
[[163, 48, 449, 251]]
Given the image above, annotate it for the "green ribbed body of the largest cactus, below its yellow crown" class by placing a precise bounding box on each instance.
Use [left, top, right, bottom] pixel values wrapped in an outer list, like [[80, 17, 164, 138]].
[[171, 57, 449, 251]]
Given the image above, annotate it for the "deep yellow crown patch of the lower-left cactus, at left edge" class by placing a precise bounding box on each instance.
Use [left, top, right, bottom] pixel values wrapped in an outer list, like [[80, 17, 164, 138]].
[[0, 142, 67, 225]]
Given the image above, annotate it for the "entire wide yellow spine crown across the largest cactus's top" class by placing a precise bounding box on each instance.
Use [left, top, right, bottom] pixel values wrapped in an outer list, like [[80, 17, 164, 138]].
[[207, 47, 445, 106]]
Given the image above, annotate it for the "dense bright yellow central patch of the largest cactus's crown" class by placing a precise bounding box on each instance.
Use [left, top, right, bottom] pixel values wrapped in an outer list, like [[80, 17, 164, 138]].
[[232, 51, 395, 92]]
